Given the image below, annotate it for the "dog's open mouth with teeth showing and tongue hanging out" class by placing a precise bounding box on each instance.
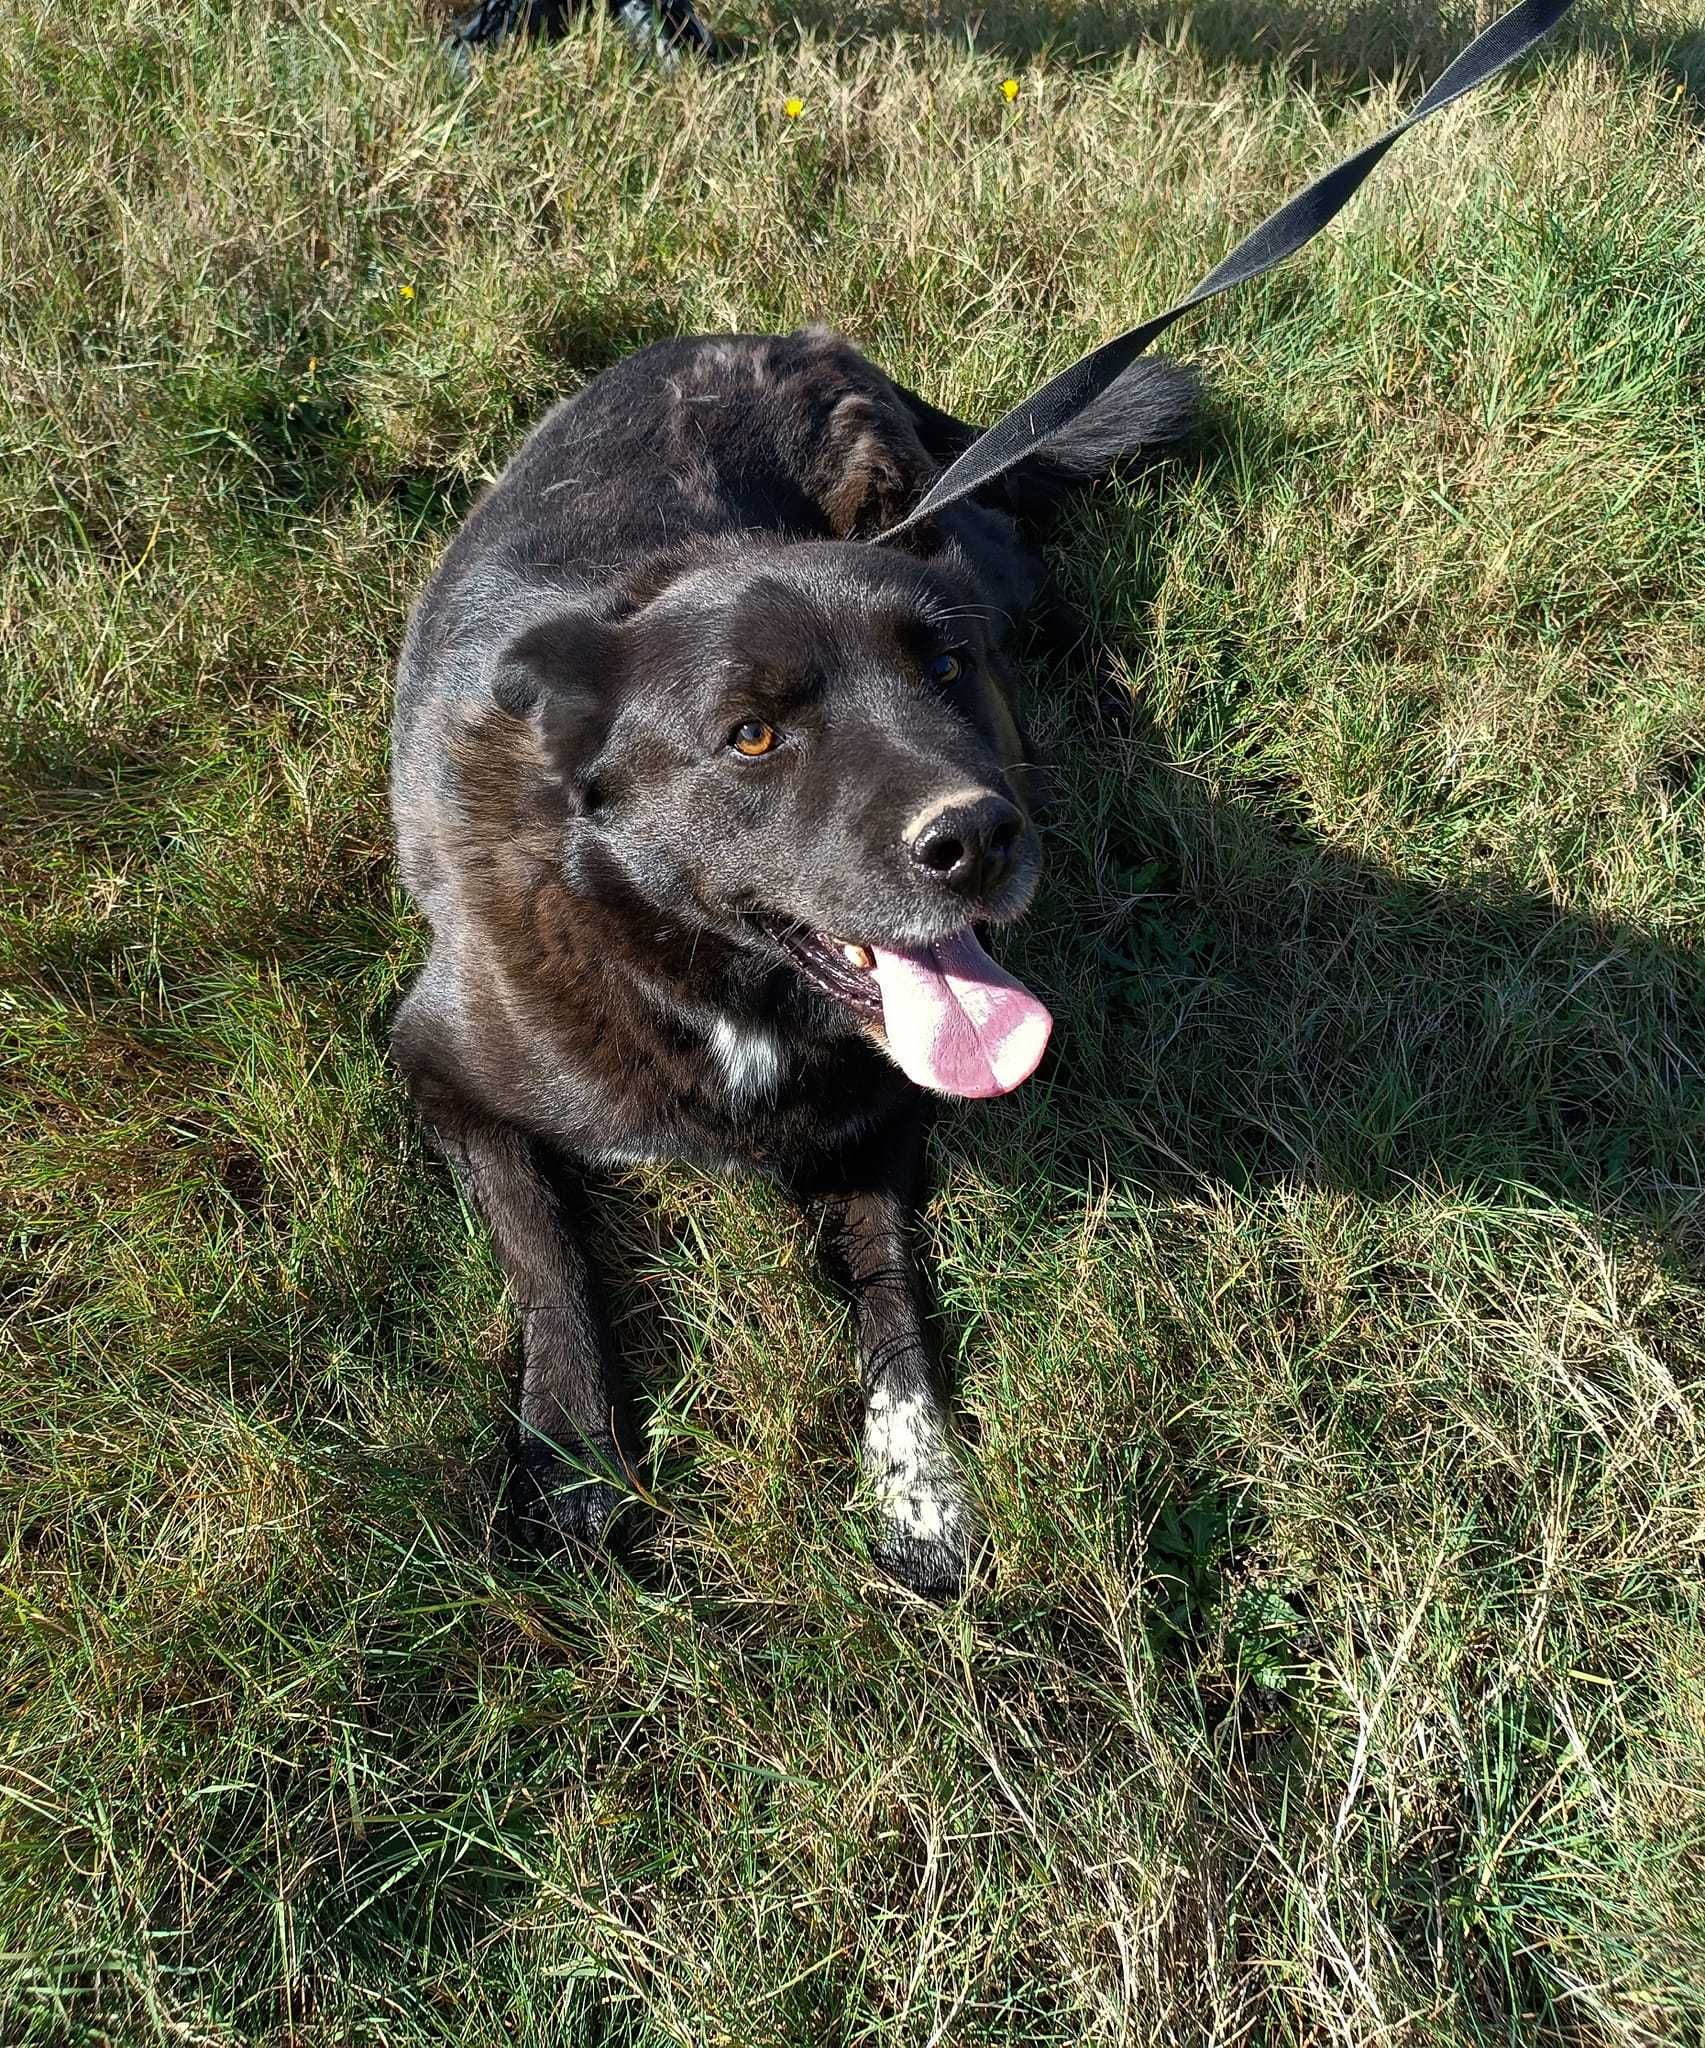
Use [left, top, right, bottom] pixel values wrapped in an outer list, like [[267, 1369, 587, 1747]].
[[772, 924, 1054, 1096]]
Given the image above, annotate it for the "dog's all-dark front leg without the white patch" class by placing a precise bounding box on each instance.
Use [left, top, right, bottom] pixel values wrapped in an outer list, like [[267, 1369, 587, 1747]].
[[413, 1104, 632, 1550]]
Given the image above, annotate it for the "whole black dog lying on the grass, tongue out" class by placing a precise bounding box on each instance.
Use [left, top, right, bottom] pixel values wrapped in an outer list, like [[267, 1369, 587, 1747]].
[[393, 330, 1193, 1591]]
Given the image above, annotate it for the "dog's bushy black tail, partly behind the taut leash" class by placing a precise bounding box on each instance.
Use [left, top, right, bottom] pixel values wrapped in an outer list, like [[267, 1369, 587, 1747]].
[[897, 356, 1201, 518]]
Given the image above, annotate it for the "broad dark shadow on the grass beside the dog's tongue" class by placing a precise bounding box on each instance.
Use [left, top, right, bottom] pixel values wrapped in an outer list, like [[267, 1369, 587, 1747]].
[[944, 757, 1705, 1264]]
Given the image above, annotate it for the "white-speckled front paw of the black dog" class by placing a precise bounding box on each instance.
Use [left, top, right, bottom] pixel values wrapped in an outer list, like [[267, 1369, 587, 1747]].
[[864, 1386, 978, 1599]]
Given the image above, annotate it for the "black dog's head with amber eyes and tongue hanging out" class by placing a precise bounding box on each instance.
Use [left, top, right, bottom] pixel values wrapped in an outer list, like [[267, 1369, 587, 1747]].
[[472, 541, 1048, 1096]]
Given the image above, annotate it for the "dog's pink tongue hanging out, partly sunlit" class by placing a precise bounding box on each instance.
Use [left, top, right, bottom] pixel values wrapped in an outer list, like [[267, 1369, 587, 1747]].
[[870, 930, 1054, 1096]]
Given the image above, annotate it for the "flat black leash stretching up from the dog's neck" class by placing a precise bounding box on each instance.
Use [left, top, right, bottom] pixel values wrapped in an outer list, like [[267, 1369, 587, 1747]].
[[876, 0, 1574, 541]]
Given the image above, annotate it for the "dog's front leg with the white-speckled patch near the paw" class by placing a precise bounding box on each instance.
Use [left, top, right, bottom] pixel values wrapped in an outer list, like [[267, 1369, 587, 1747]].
[[811, 1112, 976, 1595]]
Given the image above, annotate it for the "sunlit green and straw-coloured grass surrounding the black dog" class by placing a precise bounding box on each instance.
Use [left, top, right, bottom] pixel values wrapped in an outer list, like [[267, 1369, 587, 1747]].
[[0, 0, 1705, 2048]]
